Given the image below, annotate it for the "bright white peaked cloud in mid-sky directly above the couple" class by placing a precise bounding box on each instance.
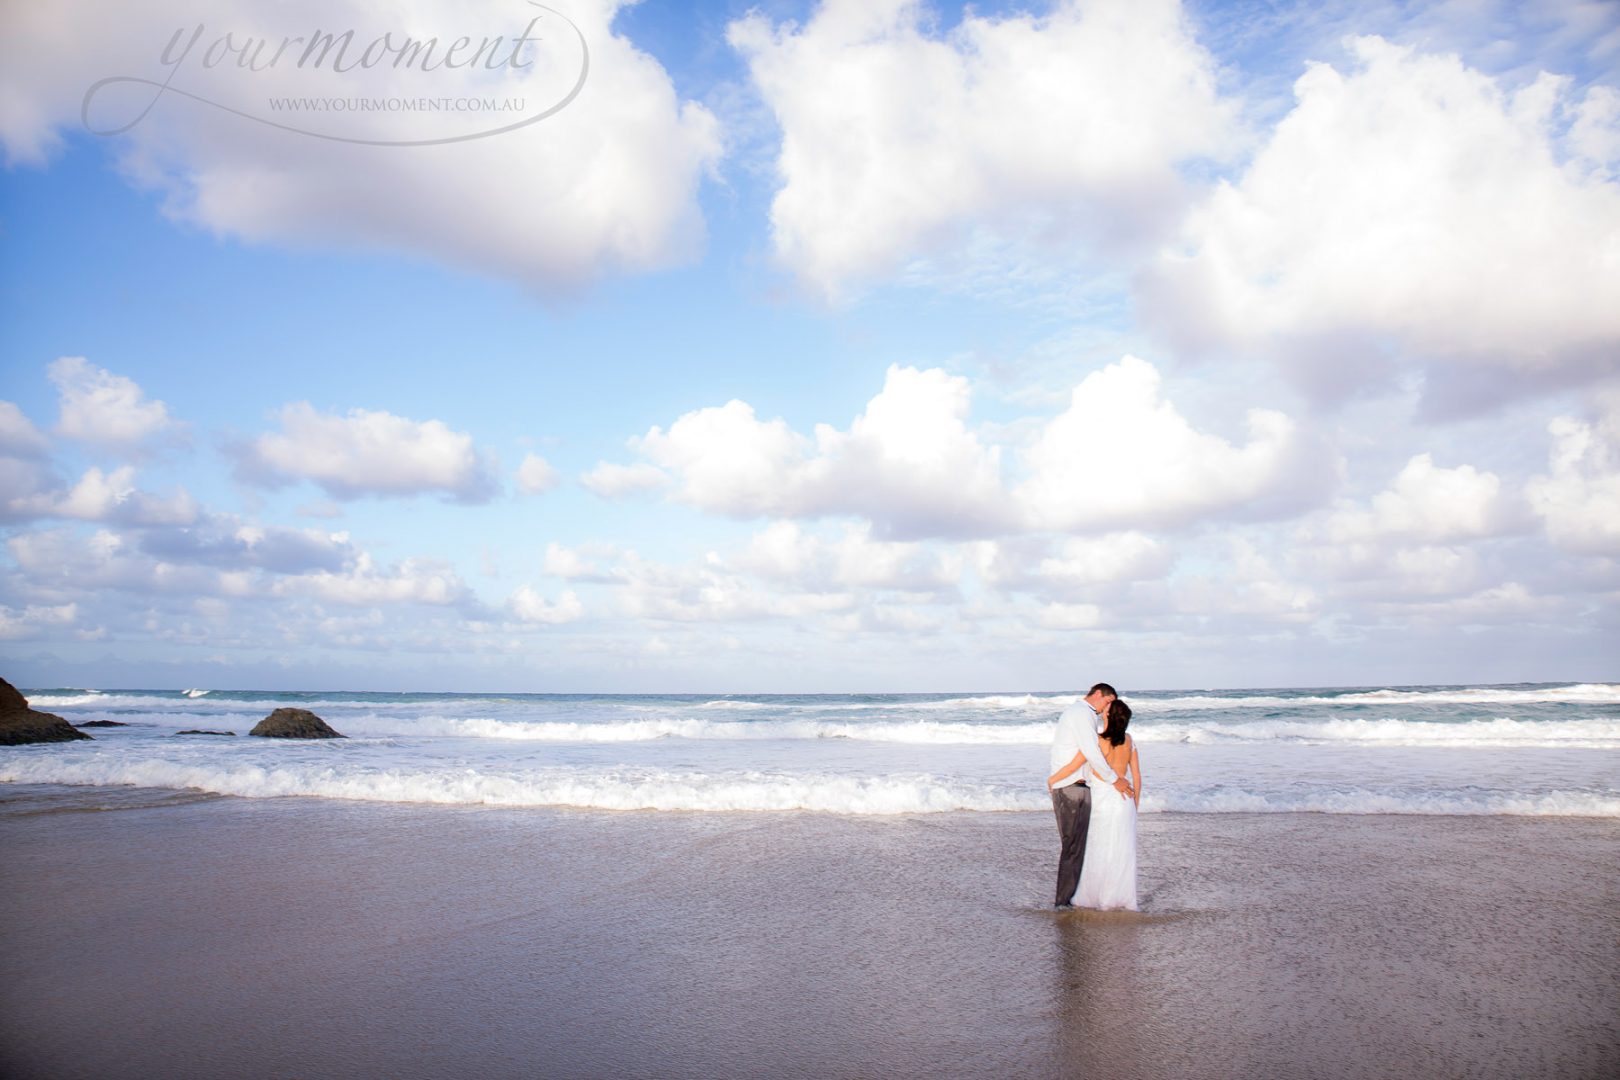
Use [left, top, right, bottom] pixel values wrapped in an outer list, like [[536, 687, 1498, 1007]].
[[1016, 356, 1333, 531]]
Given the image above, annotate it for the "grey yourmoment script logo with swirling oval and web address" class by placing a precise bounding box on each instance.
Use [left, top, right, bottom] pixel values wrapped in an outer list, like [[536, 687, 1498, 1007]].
[[81, 0, 590, 146]]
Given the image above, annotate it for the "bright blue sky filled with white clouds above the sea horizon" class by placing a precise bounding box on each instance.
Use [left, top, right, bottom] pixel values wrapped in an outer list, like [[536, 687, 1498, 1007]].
[[0, 0, 1620, 693]]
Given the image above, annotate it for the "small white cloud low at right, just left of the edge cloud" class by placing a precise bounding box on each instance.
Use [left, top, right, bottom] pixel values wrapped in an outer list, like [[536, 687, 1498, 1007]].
[[1322, 453, 1513, 544]]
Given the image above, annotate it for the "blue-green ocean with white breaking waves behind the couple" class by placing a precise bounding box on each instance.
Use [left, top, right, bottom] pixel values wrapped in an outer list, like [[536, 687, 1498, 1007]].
[[0, 683, 1620, 818]]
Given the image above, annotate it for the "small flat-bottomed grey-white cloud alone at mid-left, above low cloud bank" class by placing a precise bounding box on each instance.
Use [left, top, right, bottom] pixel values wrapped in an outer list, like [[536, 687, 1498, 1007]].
[[237, 402, 496, 502]]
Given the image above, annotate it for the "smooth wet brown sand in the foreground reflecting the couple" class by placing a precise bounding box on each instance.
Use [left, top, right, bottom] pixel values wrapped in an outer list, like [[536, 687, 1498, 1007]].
[[0, 785, 1620, 1080]]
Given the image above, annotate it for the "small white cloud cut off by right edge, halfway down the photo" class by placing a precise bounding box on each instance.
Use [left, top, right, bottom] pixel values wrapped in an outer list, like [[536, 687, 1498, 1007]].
[[1526, 408, 1620, 555]]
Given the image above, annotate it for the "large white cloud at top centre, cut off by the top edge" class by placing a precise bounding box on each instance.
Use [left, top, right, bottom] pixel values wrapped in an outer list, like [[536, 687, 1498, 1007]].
[[727, 0, 1233, 296]]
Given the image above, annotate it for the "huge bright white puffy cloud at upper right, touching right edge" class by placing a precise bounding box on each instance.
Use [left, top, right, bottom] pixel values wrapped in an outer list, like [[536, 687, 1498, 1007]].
[[1144, 37, 1620, 399]]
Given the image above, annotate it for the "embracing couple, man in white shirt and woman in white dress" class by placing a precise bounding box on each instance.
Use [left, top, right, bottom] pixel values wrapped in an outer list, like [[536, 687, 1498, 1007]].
[[1047, 683, 1142, 912]]
